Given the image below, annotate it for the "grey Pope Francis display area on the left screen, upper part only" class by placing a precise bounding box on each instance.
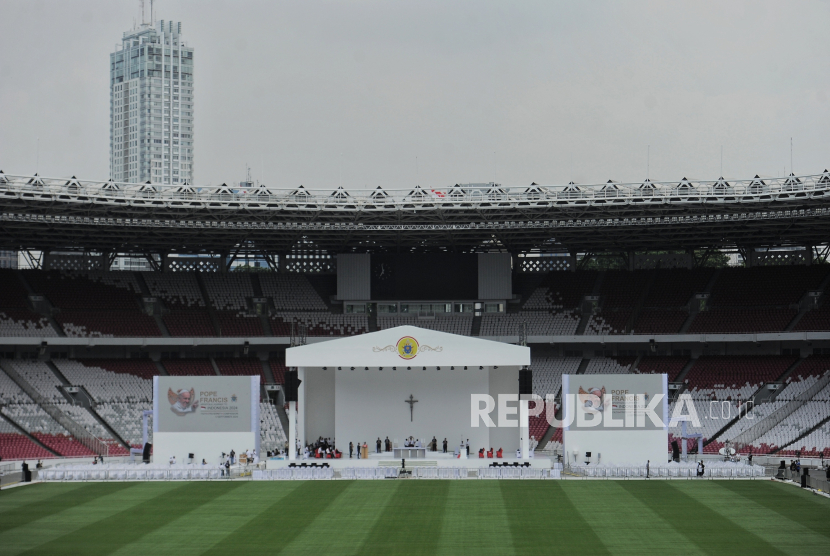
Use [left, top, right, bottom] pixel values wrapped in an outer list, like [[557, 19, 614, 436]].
[[153, 376, 259, 432]]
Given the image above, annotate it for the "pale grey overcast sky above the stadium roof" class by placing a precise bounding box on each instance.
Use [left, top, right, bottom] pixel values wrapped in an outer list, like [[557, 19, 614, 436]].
[[0, 0, 830, 188]]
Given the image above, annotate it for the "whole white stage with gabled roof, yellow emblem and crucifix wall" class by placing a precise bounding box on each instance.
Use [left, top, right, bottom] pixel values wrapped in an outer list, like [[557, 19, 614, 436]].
[[286, 326, 530, 466]]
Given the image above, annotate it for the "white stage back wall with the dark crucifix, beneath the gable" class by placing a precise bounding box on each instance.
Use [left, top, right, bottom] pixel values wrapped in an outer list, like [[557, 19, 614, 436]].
[[304, 367, 519, 457]]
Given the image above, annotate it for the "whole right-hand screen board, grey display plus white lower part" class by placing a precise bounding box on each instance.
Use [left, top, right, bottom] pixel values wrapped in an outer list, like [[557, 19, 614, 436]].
[[562, 374, 669, 465]]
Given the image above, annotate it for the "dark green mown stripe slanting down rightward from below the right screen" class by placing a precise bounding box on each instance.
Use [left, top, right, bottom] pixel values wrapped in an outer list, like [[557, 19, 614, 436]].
[[620, 480, 783, 554]]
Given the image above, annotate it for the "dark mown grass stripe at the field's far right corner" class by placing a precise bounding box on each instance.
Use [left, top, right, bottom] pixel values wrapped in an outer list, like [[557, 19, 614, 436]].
[[718, 481, 830, 537]]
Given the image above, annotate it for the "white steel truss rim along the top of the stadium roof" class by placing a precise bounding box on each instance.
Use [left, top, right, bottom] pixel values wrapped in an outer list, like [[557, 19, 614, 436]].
[[0, 173, 830, 210]]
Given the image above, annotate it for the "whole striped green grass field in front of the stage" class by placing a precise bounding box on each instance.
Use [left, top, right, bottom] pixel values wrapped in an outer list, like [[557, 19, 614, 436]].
[[0, 480, 830, 556]]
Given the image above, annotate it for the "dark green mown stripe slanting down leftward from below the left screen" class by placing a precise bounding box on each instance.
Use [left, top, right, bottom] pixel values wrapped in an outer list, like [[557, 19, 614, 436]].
[[20, 482, 244, 556]]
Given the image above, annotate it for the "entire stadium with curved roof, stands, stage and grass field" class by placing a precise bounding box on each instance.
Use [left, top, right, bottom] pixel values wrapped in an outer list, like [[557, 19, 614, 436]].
[[0, 170, 830, 554]]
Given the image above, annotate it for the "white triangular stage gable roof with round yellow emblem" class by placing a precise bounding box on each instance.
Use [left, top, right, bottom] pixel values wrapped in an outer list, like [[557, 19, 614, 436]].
[[285, 326, 530, 370]]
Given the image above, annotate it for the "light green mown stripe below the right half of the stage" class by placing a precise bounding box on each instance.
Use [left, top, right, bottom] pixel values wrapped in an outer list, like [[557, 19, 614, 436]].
[[437, 481, 516, 556]]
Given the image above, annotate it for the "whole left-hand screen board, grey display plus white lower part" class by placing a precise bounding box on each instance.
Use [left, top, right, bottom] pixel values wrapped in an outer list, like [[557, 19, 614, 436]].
[[153, 376, 259, 465]]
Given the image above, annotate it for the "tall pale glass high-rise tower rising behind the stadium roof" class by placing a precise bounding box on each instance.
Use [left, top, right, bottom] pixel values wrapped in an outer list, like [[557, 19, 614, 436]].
[[110, 17, 193, 184]]
